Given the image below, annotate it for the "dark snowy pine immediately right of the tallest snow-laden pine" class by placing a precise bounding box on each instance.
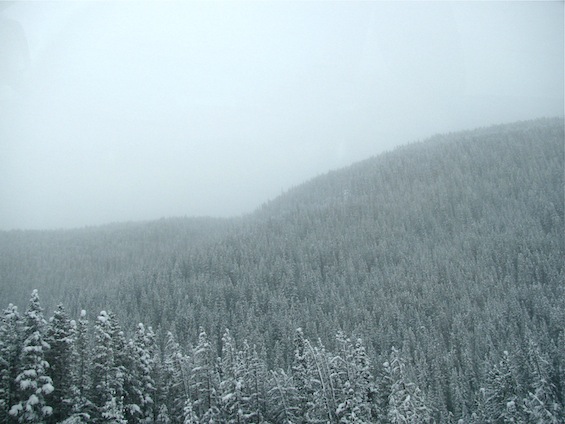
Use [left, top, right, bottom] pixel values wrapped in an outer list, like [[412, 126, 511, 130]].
[[45, 305, 74, 423]]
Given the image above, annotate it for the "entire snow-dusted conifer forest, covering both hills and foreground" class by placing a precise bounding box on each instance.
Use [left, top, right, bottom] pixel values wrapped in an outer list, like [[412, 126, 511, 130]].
[[0, 118, 565, 423]]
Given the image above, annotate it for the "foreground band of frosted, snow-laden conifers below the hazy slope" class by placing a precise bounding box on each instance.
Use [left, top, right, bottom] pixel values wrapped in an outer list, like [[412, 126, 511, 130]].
[[0, 290, 563, 424]]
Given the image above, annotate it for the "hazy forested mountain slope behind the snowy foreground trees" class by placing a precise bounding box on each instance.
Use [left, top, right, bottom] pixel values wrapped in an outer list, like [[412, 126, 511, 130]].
[[0, 119, 565, 419]]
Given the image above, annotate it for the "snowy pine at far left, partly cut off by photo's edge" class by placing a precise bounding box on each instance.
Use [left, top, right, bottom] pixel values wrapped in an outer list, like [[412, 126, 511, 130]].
[[0, 303, 23, 423]]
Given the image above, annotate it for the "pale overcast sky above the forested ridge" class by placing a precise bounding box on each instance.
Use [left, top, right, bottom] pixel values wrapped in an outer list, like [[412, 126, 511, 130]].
[[0, 1, 564, 230]]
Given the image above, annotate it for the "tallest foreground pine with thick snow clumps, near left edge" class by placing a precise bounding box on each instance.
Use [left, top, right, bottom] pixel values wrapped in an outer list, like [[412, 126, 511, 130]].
[[10, 290, 54, 423]]
